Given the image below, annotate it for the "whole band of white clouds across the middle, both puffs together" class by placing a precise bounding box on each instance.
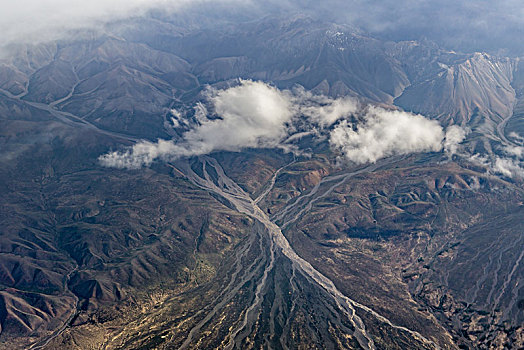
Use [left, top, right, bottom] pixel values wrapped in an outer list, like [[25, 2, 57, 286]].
[[100, 80, 466, 168]]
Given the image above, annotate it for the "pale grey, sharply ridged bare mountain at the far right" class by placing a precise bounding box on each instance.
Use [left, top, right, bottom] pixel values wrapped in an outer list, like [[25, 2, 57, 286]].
[[395, 53, 515, 128]]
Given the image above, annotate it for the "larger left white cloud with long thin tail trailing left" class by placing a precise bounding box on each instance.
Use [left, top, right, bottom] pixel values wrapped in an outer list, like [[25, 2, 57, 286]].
[[100, 80, 296, 168]]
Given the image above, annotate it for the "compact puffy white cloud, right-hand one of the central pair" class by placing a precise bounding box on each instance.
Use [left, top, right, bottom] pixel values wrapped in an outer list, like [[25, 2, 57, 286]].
[[329, 107, 444, 163]]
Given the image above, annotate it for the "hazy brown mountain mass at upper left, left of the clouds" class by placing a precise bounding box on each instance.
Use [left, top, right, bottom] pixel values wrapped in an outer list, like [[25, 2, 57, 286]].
[[0, 37, 195, 138]]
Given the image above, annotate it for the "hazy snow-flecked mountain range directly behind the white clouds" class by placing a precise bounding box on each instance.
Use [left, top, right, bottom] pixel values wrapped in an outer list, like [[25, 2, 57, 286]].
[[133, 16, 408, 102]]
